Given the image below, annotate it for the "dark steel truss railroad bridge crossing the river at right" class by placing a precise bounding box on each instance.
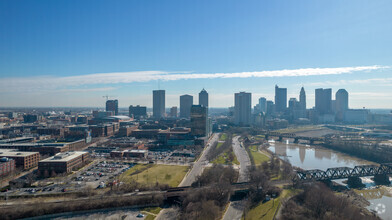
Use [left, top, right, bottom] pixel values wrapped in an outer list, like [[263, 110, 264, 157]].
[[293, 163, 392, 184]]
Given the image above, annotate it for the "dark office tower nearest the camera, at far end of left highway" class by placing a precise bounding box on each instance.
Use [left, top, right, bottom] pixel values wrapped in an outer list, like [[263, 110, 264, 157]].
[[191, 105, 208, 137]]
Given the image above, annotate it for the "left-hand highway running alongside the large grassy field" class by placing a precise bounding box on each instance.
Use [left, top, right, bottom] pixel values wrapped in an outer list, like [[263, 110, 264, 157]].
[[179, 133, 219, 187]]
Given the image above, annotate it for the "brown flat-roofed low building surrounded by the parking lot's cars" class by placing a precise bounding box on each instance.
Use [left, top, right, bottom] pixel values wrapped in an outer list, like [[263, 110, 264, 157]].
[[38, 151, 89, 176]]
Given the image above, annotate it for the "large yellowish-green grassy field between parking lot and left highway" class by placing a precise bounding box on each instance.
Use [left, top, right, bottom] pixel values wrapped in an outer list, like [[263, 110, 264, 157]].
[[121, 164, 189, 187]]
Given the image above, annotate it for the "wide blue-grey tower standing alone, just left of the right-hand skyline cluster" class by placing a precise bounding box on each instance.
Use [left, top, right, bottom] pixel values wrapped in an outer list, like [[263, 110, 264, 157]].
[[234, 92, 252, 125]]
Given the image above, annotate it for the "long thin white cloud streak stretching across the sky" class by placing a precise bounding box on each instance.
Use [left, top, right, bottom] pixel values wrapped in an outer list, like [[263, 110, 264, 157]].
[[0, 65, 389, 93]]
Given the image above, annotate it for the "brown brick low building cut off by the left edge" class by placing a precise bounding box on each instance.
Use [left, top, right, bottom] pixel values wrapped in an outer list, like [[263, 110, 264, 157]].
[[0, 149, 40, 170]]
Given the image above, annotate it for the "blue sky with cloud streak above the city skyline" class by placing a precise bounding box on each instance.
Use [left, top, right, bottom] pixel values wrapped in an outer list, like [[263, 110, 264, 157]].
[[0, 0, 392, 108]]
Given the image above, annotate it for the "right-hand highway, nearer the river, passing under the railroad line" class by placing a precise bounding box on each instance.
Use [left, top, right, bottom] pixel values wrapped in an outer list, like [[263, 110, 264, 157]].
[[223, 136, 251, 220]]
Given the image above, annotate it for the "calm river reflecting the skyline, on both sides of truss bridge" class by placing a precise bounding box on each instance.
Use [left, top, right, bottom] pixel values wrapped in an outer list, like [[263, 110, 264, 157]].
[[268, 140, 392, 220]]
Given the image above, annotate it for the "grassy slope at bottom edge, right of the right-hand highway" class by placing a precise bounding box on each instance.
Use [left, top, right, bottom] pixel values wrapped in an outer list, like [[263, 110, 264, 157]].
[[242, 189, 300, 220]]
